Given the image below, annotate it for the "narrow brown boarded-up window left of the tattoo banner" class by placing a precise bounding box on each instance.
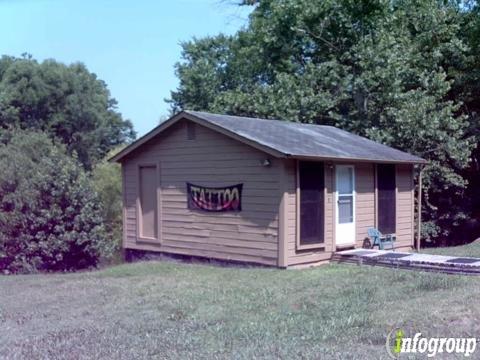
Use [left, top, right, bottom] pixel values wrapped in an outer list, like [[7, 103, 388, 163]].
[[139, 165, 157, 239]]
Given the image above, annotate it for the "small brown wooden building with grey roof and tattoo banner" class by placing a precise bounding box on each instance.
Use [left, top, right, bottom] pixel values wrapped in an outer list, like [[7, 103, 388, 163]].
[[111, 111, 425, 268]]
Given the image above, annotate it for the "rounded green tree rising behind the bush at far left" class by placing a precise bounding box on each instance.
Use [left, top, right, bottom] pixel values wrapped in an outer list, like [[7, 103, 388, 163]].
[[0, 55, 135, 169]]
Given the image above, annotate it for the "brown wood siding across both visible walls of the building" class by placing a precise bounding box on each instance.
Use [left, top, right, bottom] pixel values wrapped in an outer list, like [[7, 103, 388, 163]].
[[122, 120, 414, 267]]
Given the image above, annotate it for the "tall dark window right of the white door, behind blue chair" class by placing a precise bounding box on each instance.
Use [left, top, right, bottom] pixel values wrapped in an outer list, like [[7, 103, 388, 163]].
[[377, 164, 396, 234]]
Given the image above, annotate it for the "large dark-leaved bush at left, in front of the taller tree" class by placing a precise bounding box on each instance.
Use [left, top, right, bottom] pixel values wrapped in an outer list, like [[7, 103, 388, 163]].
[[0, 130, 112, 273]]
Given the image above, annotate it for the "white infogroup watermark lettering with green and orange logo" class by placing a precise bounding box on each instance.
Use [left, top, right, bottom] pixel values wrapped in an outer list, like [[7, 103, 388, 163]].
[[386, 328, 477, 359]]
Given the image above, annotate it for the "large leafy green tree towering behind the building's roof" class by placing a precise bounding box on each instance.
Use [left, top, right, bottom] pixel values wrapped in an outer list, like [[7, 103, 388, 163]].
[[170, 0, 479, 243]]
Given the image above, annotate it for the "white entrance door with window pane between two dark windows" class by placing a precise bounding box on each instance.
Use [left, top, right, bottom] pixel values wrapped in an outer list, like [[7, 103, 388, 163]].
[[335, 165, 355, 246]]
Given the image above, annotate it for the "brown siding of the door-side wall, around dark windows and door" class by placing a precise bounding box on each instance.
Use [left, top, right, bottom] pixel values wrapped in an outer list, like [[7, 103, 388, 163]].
[[286, 160, 414, 266]]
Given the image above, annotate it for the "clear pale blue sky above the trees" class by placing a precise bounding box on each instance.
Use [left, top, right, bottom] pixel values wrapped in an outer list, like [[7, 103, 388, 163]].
[[0, 0, 250, 135]]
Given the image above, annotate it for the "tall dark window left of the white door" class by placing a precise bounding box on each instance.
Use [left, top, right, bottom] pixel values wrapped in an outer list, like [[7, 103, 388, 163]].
[[299, 161, 325, 245]]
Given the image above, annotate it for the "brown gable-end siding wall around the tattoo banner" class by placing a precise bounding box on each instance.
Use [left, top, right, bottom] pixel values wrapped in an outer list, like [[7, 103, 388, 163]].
[[122, 121, 283, 265]]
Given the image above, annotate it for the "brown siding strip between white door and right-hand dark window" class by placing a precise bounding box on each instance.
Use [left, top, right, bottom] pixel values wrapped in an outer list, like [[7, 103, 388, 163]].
[[355, 163, 375, 247]]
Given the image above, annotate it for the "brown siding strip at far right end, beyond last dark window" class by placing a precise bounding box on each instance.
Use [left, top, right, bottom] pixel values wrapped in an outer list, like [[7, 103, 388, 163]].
[[396, 165, 414, 248]]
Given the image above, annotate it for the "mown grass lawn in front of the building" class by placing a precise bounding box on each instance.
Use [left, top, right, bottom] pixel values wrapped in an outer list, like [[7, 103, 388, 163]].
[[0, 243, 480, 359]]
